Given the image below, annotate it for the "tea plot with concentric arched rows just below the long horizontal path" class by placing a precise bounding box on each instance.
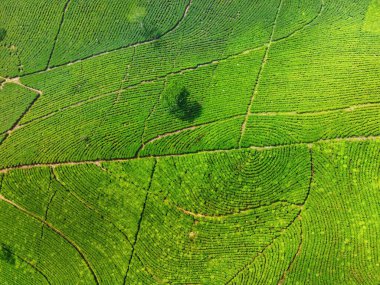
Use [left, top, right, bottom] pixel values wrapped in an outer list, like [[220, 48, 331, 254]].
[[153, 144, 310, 215]]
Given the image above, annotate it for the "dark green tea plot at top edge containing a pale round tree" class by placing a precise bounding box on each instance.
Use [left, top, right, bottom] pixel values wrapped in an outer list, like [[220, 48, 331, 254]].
[[48, 0, 188, 66]]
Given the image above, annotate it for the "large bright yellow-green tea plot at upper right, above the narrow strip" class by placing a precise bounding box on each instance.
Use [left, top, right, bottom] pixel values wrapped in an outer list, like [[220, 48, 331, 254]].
[[252, 0, 380, 112]]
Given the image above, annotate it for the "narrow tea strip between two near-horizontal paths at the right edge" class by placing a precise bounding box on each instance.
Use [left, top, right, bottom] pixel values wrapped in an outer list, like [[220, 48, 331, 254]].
[[242, 104, 380, 146]]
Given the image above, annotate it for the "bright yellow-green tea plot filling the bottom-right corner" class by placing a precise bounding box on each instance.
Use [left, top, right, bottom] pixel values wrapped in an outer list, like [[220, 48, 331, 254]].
[[288, 141, 380, 284]]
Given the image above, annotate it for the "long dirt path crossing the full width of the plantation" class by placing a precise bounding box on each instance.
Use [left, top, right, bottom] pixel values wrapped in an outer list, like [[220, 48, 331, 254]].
[[0, 136, 380, 173]]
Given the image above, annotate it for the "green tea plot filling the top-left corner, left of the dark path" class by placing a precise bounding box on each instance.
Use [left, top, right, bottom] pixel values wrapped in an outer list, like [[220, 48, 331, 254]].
[[0, 0, 70, 77]]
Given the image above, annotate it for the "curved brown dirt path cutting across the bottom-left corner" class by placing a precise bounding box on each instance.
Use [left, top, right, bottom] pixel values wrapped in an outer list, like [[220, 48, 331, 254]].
[[0, 194, 99, 285]]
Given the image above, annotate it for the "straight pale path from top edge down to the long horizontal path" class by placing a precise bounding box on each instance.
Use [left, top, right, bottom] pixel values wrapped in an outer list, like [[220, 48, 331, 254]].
[[239, 0, 284, 148]]
